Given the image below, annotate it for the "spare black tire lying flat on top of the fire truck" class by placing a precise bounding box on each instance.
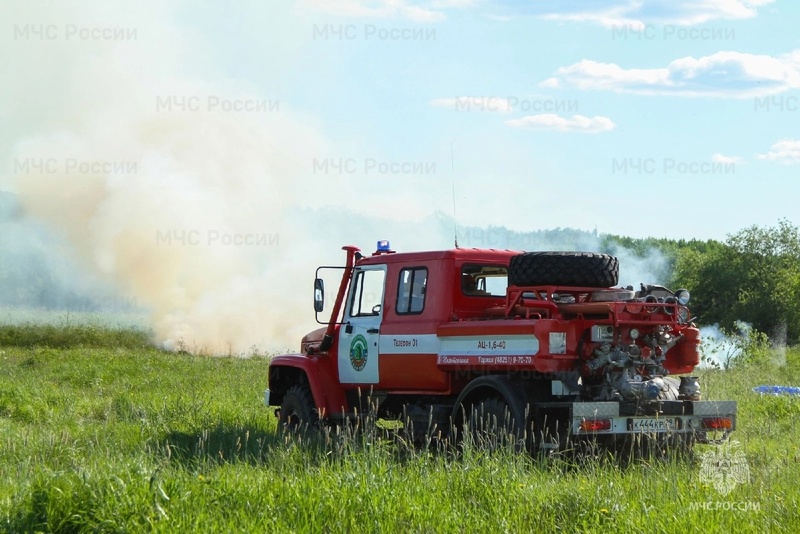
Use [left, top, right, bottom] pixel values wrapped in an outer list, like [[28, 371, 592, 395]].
[[508, 252, 619, 287]]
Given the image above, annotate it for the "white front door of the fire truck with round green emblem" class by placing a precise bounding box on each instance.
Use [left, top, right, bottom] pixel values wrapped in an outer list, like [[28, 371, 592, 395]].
[[338, 265, 386, 384]]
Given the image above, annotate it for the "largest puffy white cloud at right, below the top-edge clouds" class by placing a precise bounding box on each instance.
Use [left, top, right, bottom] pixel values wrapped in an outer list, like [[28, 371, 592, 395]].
[[540, 49, 800, 98]]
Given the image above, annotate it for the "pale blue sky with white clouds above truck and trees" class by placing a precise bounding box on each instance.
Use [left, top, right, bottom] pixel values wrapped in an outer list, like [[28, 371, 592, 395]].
[[222, 0, 800, 239]]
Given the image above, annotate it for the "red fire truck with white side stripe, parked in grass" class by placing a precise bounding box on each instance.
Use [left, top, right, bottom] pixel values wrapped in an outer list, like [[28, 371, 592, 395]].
[[265, 241, 736, 450]]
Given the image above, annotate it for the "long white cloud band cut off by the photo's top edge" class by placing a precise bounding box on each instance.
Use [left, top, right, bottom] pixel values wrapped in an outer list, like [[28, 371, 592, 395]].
[[302, 0, 774, 29]]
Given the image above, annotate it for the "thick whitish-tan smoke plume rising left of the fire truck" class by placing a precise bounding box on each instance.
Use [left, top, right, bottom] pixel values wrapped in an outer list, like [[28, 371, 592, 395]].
[[1, 3, 338, 353]]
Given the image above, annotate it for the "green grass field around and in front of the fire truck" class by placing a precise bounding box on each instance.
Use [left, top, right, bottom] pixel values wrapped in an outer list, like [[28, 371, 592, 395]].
[[0, 324, 800, 533]]
